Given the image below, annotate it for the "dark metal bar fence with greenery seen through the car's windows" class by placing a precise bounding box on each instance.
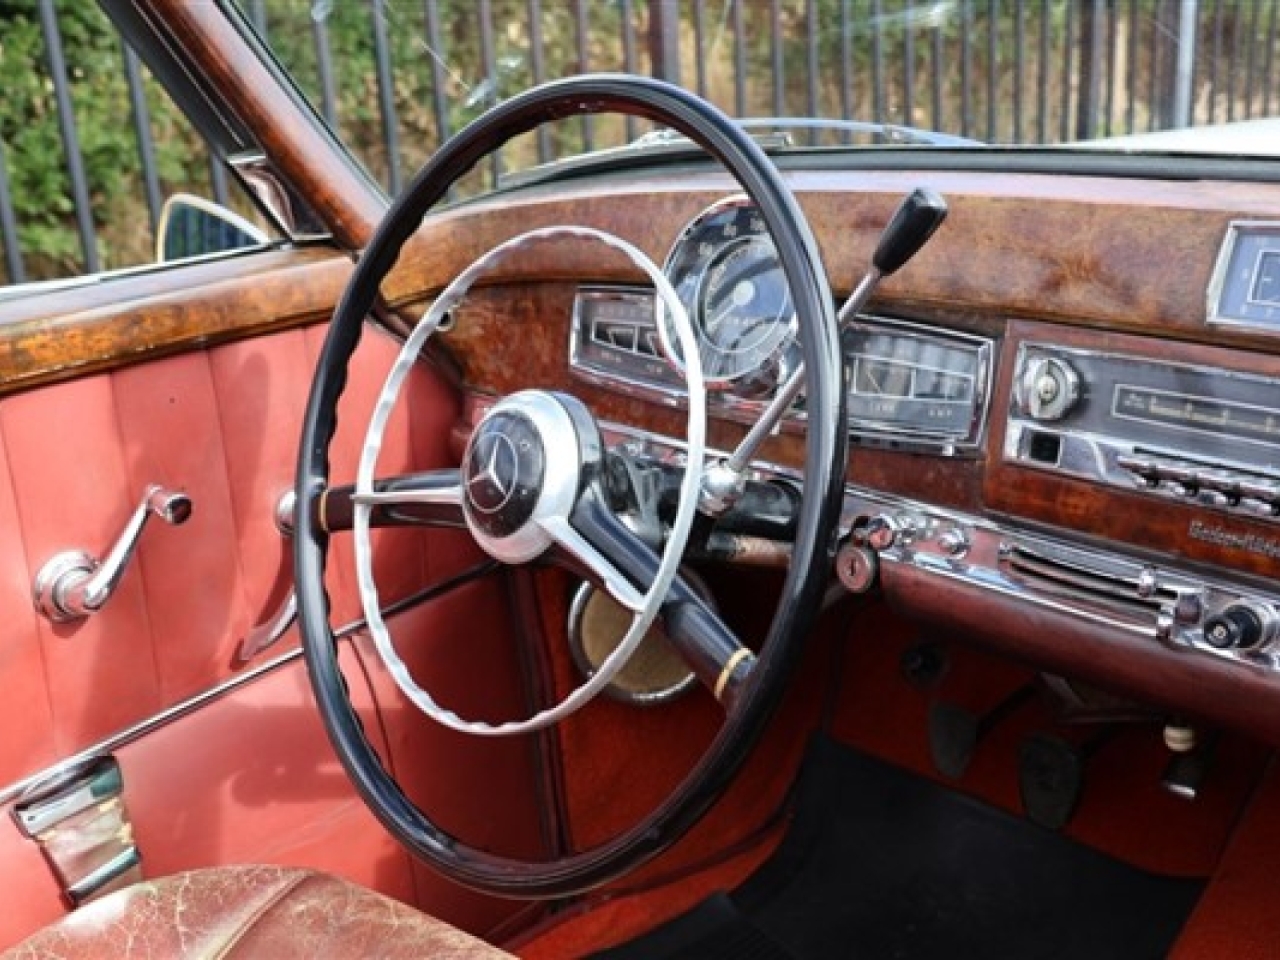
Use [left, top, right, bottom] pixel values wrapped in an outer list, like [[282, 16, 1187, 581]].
[[0, 0, 1280, 289]]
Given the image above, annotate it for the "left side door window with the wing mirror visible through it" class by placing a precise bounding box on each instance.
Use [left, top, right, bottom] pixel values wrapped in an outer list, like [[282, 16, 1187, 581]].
[[0, 0, 277, 296]]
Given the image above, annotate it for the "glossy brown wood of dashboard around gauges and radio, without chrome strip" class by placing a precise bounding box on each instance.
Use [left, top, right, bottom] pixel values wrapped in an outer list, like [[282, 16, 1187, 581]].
[[427, 165, 1280, 563]]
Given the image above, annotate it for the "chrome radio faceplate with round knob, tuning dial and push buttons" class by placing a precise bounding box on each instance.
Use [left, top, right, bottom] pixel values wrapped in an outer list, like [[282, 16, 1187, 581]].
[[1002, 340, 1280, 520]]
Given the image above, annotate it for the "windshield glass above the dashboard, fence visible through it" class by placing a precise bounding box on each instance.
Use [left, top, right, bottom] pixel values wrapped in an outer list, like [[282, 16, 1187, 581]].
[[241, 0, 1280, 192]]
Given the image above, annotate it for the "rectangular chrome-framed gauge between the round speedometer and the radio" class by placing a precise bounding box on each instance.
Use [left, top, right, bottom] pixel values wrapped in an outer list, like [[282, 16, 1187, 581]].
[[845, 316, 992, 453]]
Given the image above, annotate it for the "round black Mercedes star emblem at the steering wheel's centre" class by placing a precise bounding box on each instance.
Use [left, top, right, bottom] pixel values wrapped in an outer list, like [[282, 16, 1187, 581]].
[[462, 410, 545, 538]]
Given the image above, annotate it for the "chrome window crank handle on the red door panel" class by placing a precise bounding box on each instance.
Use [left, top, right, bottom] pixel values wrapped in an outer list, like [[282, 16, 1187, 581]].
[[32, 485, 191, 623]]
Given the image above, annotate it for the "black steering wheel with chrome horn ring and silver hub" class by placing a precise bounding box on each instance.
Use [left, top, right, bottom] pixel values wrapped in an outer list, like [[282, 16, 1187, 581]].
[[294, 74, 846, 897]]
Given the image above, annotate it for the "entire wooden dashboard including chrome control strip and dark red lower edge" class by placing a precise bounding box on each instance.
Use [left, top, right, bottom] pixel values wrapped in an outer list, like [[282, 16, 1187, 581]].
[[422, 165, 1280, 742]]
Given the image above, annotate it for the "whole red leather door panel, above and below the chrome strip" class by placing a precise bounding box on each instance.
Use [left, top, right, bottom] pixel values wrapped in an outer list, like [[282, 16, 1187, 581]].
[[0, 309, 539, 943]]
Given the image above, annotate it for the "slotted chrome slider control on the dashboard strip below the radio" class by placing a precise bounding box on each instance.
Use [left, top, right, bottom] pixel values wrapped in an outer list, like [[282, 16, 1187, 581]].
[[1000, 544, 1178, 623]]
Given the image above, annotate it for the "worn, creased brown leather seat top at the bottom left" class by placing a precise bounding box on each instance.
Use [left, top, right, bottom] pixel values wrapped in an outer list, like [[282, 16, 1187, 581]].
[[4, 867, 511, 960]]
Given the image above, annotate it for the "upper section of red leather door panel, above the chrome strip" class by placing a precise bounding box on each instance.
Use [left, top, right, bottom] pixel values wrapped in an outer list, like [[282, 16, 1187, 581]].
[[0, 323, 453, 783]]
